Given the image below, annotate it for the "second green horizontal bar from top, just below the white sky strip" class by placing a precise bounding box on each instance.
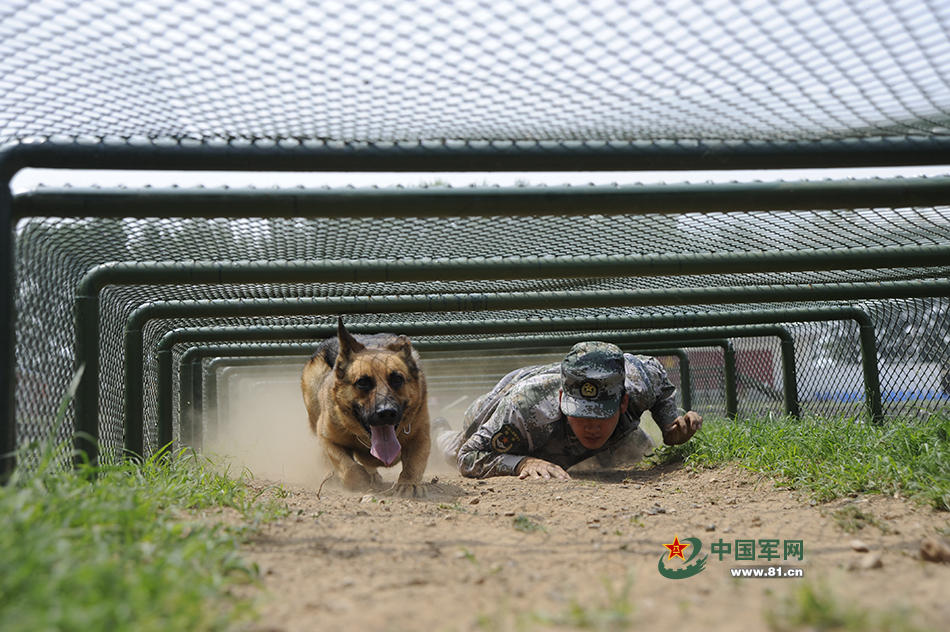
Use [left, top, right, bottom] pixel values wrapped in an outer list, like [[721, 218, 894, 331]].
[[13, 176, 950, 218]]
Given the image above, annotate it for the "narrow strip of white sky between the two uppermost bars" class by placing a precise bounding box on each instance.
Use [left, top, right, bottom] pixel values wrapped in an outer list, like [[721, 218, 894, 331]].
[[11, 165, 950, 194]]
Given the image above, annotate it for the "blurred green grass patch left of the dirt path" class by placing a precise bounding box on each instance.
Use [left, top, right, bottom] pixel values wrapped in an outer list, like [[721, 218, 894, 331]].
[[0, 448, 285, 632]]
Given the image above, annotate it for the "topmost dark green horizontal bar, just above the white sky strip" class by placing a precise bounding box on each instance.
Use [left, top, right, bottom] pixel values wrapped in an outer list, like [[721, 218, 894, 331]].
[[0, 135, 950, 173]]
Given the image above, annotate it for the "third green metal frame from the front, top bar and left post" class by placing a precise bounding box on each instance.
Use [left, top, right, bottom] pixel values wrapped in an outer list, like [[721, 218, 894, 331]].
[[76, 252, 950, 464]]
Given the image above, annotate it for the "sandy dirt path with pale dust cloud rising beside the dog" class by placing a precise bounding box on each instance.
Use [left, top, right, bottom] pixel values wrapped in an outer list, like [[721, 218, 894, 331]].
[[208, 362, 950, 632]]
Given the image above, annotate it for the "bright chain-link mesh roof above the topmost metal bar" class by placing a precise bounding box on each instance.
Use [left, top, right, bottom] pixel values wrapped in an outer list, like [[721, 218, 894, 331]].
[[0, 0, 950, 143]]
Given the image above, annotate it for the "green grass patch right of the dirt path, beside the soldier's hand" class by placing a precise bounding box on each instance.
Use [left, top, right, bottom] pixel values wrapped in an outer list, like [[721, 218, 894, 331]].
[[657, 413, 950, 511]]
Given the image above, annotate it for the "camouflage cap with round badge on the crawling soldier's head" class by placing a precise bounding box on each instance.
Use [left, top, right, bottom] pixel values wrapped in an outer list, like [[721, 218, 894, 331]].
[[561, 341, 625, 419]]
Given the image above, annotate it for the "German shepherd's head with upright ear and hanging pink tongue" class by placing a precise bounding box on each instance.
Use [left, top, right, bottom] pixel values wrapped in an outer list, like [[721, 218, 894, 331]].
[[333, 318, 425, 465]]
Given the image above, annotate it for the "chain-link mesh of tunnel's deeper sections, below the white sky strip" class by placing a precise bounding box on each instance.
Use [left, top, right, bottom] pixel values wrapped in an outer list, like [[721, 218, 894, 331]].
[[16, 202, 950, 454]]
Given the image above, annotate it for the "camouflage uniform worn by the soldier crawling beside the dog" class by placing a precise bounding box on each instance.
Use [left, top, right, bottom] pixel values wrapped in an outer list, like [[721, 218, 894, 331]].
[[437, 353, 677, 478]]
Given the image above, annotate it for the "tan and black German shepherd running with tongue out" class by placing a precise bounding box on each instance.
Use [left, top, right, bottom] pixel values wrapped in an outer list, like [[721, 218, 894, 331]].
[[300, 318, 429, 496]]
